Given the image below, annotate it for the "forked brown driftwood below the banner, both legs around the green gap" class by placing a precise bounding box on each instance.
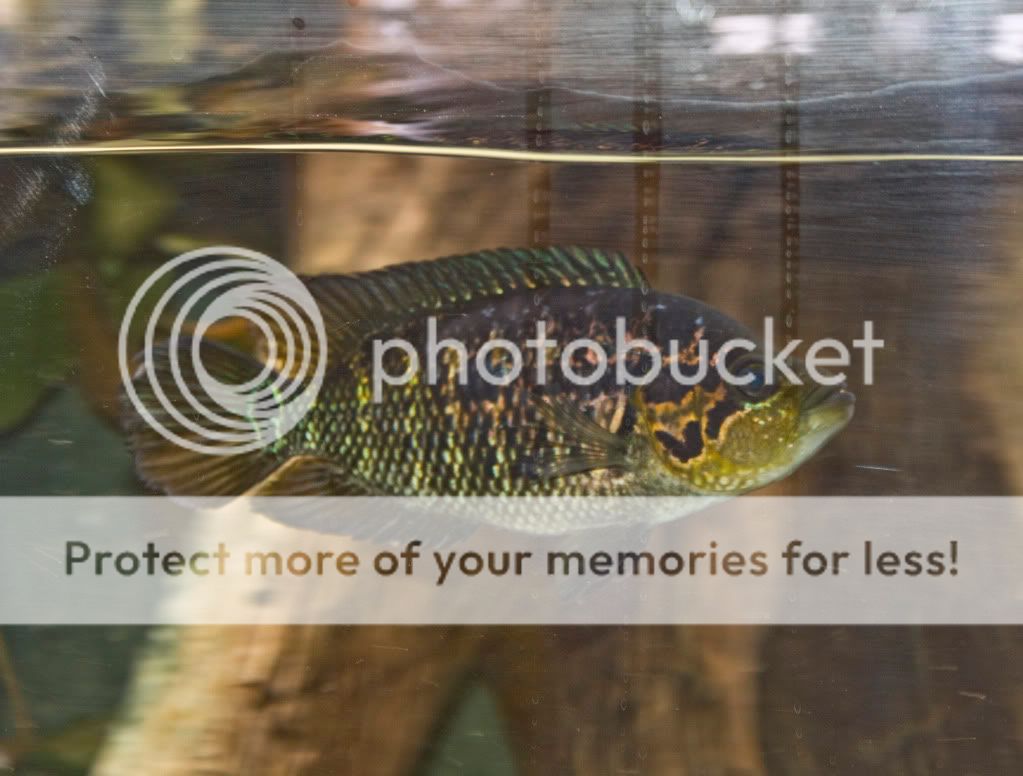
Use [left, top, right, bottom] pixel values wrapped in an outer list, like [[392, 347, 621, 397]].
[[95, 627, 762, 776]]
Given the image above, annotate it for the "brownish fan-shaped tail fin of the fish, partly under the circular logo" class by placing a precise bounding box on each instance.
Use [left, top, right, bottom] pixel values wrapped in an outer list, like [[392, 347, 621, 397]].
[[123, 338, 282, 496]]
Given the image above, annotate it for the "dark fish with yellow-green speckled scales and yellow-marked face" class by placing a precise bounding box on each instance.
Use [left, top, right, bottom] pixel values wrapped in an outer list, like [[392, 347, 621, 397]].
[[125, 246, 854, 515]]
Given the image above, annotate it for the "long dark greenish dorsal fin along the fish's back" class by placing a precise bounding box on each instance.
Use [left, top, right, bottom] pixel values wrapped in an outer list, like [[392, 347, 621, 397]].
[[303, 246, 647, 361]]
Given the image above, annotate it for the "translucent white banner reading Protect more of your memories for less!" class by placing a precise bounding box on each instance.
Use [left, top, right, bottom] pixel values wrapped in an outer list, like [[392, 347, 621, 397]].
[[0, 497, 1023, 625]]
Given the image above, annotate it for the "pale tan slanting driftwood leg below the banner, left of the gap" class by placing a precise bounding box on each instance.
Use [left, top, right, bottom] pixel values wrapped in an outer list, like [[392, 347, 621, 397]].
[[95, 627, 475, 776]]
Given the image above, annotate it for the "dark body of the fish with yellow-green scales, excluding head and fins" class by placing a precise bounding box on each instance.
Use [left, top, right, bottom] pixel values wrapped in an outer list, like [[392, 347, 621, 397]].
[[282, 288, 744, 496]]
